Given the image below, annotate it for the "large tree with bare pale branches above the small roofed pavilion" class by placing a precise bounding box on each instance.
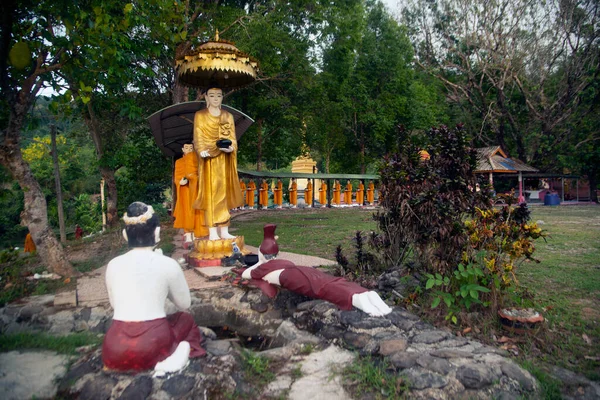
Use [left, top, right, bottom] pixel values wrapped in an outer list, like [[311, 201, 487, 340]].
[[403, 0, 600, 168]]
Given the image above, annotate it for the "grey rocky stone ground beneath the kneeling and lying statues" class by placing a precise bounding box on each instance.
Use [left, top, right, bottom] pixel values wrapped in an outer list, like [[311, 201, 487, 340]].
[[0, 230, 600, 400]]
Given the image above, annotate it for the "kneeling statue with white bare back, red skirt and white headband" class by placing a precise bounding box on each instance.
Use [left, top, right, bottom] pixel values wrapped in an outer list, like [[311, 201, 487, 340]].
[[102, 202, 206, 372]]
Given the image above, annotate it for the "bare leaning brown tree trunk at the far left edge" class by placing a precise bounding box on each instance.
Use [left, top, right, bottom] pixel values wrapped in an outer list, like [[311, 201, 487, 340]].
[[0, 132, 79, 277]]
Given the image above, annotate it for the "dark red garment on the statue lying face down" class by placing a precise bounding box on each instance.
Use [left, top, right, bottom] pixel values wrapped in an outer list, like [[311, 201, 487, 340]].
[[251, 260, 368, 310]]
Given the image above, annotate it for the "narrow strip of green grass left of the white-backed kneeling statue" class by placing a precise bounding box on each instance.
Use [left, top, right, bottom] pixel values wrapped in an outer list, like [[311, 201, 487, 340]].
[[0, 332, 102, 354]]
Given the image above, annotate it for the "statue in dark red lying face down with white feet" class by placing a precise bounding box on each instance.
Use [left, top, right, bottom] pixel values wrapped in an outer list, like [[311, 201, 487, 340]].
[[242, 224, 392, 317]]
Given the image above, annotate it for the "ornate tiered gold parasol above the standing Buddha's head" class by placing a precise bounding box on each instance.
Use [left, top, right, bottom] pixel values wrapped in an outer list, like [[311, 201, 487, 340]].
[[175, 32, 258, 89]]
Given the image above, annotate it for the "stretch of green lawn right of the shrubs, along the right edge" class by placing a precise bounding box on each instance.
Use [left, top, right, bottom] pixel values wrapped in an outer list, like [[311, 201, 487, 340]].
[[517, 206, 600, 381]]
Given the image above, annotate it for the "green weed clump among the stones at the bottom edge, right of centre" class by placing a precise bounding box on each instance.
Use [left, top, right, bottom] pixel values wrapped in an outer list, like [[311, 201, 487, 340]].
[[341, 357, 409, 399]]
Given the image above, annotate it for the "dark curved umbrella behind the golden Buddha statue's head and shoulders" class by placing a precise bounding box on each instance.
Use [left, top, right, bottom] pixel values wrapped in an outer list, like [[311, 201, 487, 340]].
[[148, 101, 254, 157]]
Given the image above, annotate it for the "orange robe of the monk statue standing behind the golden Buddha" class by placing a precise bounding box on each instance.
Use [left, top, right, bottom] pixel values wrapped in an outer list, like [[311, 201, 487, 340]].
[[173, 152, 208, 237]]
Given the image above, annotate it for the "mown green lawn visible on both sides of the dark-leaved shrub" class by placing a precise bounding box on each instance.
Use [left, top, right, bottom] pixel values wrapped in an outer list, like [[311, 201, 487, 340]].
[[231, 206, 600, 381]]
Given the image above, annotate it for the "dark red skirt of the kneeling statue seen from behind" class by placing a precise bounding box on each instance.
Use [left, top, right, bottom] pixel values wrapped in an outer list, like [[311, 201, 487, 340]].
[[102, 312, 206, 371]]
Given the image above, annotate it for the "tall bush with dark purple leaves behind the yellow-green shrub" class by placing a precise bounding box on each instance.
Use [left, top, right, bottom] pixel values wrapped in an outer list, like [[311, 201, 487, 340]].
[[372, 125, 489, 275]]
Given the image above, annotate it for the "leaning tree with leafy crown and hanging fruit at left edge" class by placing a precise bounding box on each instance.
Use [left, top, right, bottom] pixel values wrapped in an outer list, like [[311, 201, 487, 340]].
[[0, 0, 92, 276]]
